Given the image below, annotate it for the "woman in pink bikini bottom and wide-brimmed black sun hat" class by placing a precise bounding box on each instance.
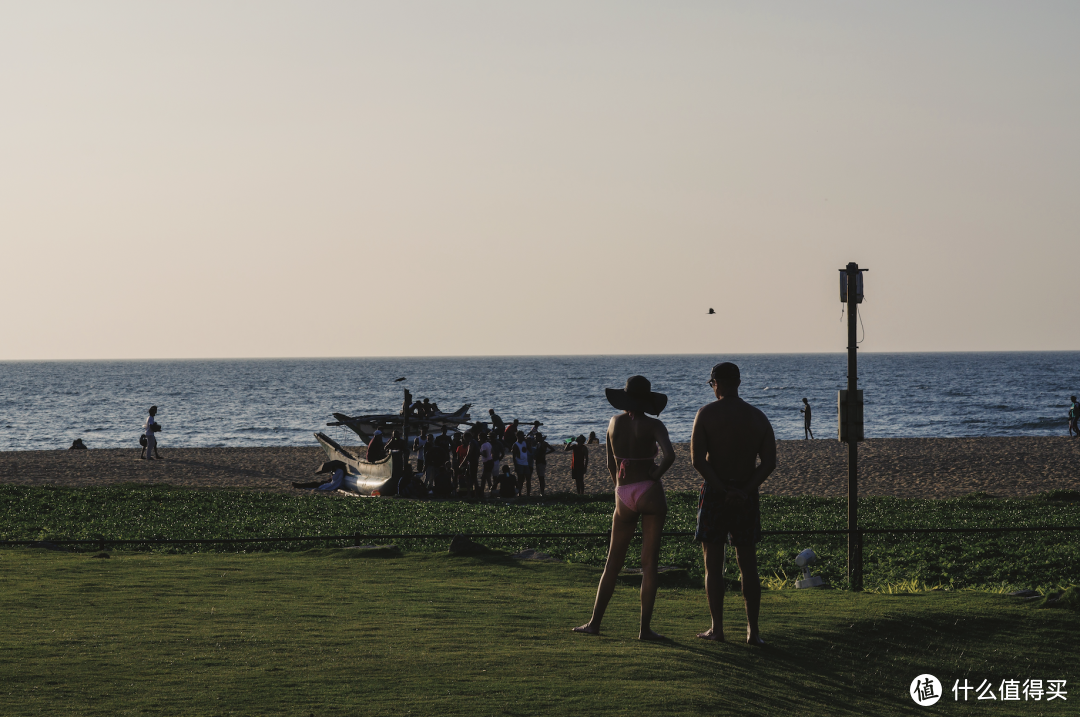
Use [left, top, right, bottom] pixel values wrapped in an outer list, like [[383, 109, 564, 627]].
[[573, 376, 675, 640]]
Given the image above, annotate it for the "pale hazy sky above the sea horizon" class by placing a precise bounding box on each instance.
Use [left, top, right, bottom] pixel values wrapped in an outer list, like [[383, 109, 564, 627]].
[[0, 0, 1080, 360]]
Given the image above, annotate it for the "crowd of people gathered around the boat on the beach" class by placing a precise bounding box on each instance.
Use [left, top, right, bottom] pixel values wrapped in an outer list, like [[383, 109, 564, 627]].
[[365, 409, 599, 500]]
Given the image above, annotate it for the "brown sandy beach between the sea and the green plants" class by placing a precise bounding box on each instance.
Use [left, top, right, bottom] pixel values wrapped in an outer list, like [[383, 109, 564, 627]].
[[0, 437, 1080, 498]]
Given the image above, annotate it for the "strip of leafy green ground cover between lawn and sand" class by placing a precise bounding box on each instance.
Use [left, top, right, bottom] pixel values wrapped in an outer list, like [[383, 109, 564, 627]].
[[0, 485, 1080, 592]]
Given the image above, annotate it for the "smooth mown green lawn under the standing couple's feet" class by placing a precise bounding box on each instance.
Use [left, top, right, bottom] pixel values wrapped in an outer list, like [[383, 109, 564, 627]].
[[0, 549, 1080, 716]]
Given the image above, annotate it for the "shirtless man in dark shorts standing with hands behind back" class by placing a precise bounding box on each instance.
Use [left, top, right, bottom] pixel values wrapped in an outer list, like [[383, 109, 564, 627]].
[[690, 363, 777, 647]]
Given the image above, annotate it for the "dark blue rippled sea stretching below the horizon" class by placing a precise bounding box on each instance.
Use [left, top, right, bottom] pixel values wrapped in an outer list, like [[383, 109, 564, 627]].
[[0, 352, 1080, 450]]
